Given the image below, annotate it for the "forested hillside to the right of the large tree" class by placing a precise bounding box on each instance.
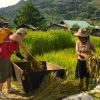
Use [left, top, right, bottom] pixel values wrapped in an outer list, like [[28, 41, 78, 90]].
[[31, 0, 100, 23]]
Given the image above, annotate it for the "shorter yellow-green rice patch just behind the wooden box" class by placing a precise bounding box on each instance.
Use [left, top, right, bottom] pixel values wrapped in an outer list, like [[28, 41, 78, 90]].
[[35, 48, 77, 77]]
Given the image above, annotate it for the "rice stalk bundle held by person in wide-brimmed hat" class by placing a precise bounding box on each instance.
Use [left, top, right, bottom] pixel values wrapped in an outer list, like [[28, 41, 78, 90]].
[[86, 54, 100, 78]]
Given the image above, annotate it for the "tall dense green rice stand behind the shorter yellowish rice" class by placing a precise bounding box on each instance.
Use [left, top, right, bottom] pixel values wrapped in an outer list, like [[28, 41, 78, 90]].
[[20, 30, 75, 55]]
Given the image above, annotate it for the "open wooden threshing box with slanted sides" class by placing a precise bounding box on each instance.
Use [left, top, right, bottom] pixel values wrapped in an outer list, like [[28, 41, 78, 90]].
[[12, 61, 66, 93]]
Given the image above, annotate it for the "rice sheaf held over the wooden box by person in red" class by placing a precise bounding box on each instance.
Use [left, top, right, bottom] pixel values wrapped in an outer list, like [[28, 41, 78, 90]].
[[27, 55, 43, 71]]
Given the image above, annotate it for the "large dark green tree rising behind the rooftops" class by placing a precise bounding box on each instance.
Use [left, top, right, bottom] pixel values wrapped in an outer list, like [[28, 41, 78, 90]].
[[14, 2, 45, 29]]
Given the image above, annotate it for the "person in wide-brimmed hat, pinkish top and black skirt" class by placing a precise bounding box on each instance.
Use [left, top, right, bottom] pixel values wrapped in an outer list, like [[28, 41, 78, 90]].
[[74, 28, 96, 90]]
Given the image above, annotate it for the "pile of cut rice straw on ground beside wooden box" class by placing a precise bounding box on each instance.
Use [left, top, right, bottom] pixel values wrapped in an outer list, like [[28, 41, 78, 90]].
[[32, 72, 78, 100]]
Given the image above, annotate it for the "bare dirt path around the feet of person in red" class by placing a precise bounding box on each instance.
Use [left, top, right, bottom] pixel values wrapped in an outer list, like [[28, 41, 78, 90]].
[[0, 83, 30, 100]]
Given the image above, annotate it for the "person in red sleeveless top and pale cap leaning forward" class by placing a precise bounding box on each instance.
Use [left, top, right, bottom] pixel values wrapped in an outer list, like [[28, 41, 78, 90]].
[[0, 28, 32, 99]]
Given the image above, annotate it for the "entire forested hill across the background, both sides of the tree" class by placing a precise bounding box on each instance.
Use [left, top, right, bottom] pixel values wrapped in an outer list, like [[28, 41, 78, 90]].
[[0, 0, 100, 25]]
